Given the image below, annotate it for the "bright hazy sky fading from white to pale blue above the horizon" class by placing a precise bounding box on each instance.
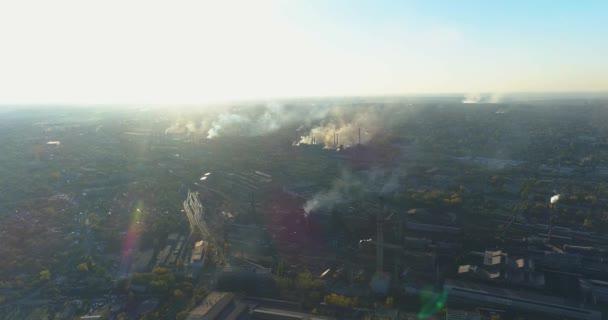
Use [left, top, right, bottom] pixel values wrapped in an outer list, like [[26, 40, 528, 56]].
[[0, 0, 608, 104]]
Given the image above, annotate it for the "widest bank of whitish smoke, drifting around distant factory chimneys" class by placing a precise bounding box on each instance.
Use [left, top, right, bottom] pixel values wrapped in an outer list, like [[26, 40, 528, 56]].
[[165, 103, 396, 142]]
